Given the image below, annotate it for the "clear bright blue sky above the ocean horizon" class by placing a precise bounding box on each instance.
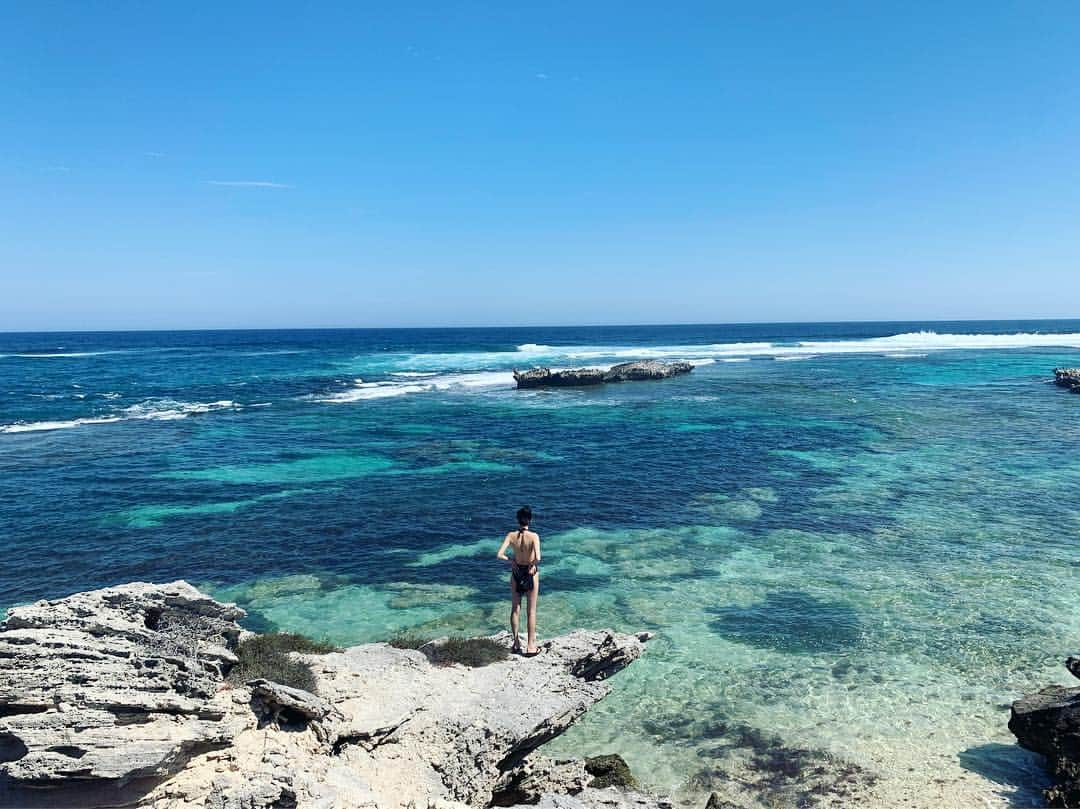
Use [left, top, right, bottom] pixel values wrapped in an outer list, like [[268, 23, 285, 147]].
[[0, 1, 1080, 329]]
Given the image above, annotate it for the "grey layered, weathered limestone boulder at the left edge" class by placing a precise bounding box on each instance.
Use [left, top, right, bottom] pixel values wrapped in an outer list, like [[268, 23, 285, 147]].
[[0, 581, 244, 785]]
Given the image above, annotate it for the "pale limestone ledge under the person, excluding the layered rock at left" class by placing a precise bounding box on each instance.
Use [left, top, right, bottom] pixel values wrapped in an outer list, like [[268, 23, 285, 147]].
[[139, 631, 644, 809]]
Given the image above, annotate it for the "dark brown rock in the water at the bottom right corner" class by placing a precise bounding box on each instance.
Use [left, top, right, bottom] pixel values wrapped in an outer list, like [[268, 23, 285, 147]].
[[1009, 658, 1080, 807]]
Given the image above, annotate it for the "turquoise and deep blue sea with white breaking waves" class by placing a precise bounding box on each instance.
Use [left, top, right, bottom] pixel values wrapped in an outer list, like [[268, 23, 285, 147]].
[[0, 322, 1080, 807]]
